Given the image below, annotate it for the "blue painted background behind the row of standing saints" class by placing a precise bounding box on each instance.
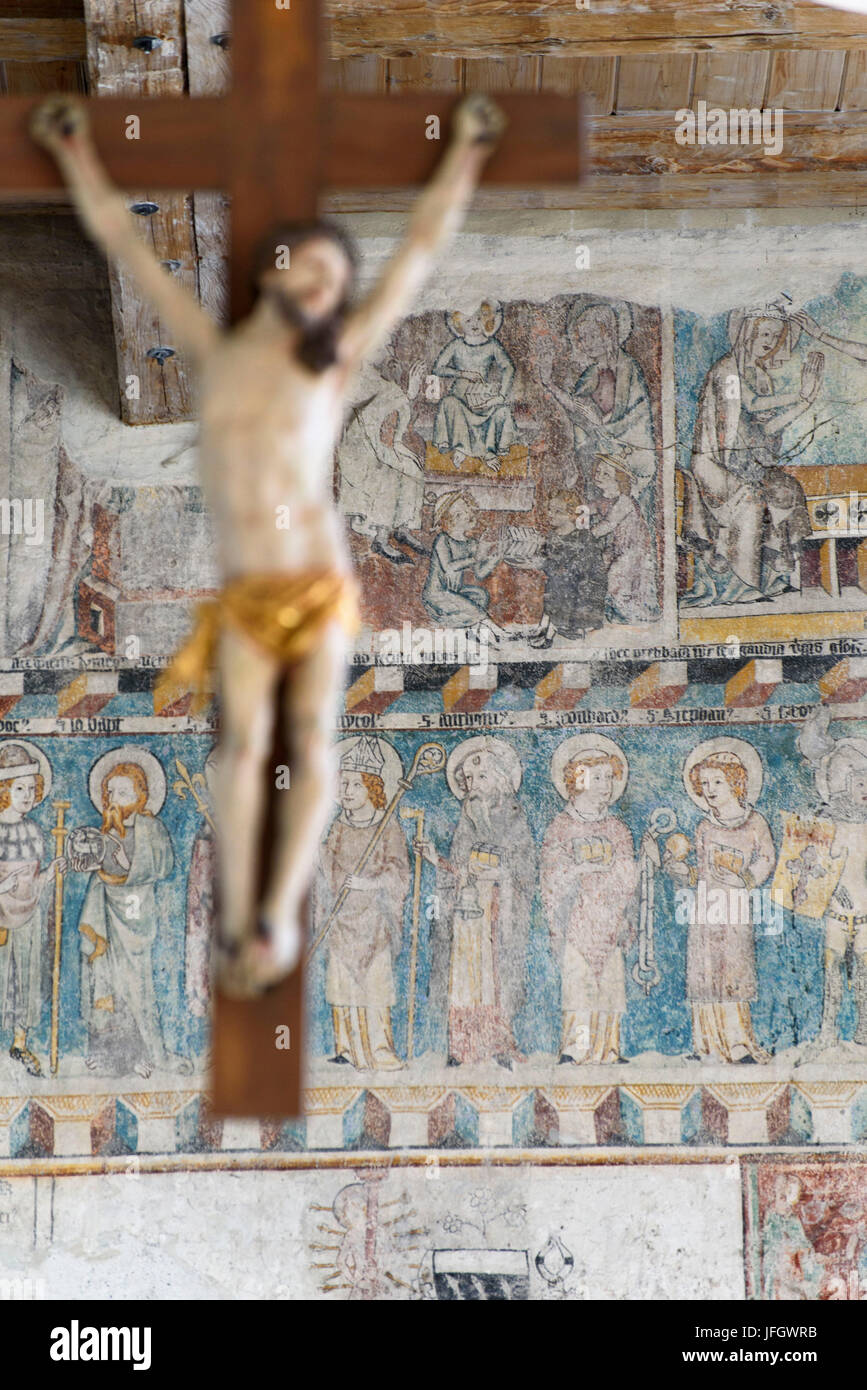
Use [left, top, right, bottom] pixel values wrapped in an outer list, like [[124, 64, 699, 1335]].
[[3, 720, 867, 1056]]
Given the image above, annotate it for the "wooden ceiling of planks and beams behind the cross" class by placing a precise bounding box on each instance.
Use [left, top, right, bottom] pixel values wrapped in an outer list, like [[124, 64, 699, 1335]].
[[0, 0, 867, 424]]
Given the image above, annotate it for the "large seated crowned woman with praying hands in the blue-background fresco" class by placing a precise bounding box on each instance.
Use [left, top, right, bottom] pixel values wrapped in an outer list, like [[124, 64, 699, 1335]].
[[681, 309, 824, 607]]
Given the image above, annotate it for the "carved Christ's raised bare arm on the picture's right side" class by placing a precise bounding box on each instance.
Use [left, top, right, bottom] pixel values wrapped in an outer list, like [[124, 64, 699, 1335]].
[[340, 95, 506, 368]]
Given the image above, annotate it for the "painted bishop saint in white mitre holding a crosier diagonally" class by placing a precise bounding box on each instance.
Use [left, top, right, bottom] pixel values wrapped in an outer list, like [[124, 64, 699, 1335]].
[[314, 737, 410, 1072]]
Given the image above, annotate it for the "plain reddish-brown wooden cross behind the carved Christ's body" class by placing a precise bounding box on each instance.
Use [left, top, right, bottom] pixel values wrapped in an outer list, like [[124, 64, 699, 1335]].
[[0, 0, 581, 1116]]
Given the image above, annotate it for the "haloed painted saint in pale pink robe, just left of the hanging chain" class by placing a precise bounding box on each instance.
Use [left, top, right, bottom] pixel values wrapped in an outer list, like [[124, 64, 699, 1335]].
[[539, 734, 638, 1063]]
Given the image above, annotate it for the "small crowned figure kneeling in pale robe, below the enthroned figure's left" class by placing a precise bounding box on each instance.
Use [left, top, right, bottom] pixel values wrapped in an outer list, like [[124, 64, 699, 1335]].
[[421, 492, 509, 642]]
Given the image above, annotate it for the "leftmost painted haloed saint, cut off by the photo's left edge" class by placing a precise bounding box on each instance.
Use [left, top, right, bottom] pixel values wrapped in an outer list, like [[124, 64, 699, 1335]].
[[0, 742, 65, 1076]]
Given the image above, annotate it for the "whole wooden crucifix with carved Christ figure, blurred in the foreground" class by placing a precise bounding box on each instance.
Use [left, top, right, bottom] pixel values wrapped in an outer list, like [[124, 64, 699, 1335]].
[[0, 0, 581, 1116]]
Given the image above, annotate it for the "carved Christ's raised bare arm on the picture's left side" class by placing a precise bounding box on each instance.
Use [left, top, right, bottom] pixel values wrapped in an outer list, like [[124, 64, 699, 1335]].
[[31, 96, 220, 360]]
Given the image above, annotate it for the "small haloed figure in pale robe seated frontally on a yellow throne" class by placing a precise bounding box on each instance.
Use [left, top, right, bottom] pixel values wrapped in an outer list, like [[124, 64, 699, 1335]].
[[431, 300, 517, 473]]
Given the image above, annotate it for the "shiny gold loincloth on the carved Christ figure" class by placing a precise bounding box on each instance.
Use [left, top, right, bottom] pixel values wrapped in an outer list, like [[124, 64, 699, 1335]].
[[154, 570, 358, 714]]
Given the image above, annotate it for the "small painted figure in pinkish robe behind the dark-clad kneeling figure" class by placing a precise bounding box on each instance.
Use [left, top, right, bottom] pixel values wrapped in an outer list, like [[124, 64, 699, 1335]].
[[592, 455, 659, 623]]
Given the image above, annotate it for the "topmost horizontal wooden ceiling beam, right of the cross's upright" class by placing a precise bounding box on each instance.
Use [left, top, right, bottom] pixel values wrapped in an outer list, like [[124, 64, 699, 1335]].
[[327, 0, 867, 58]]
